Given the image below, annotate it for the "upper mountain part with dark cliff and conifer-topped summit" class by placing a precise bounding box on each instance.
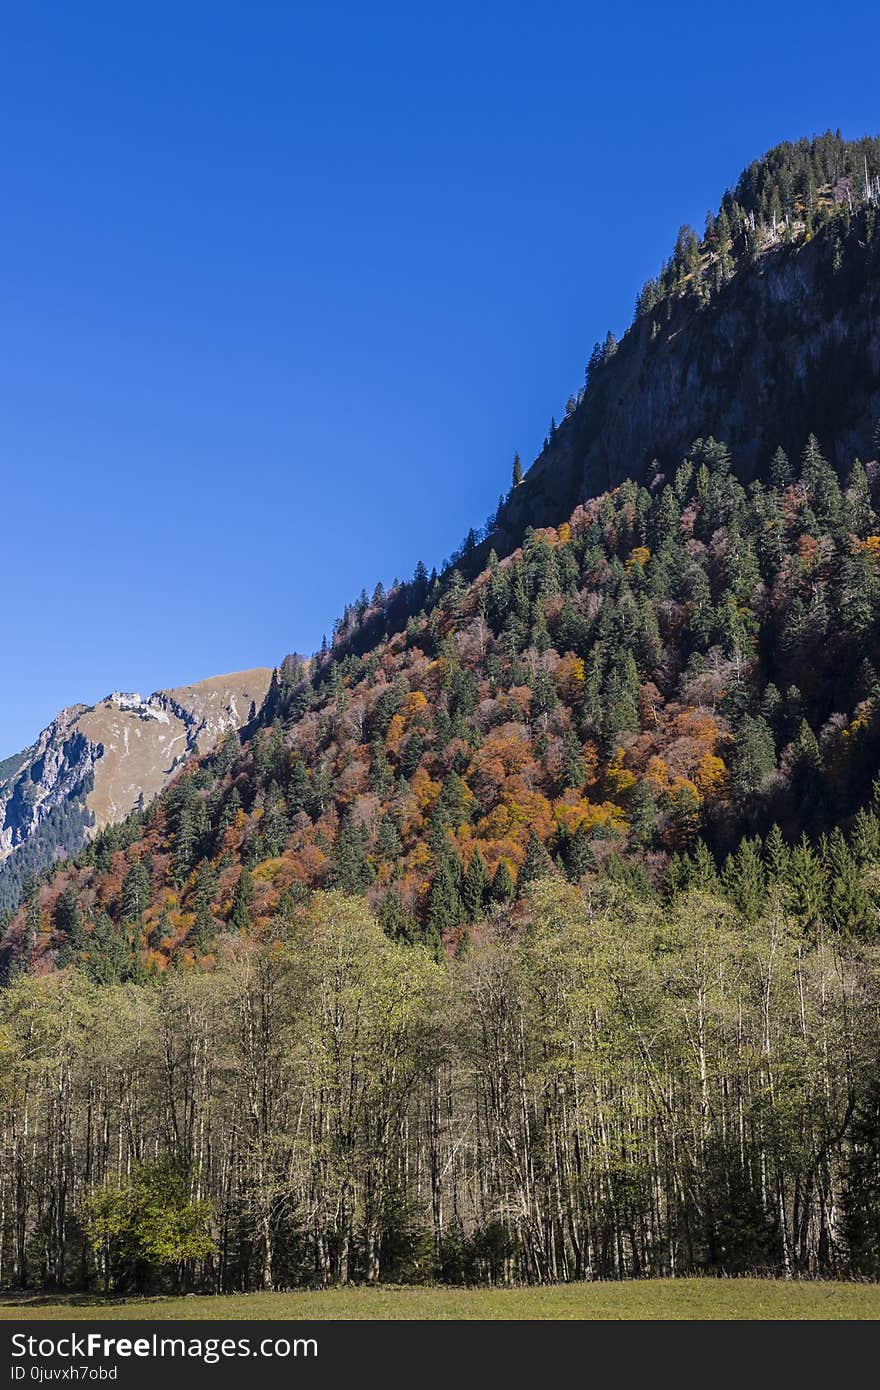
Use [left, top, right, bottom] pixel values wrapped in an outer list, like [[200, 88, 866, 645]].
[[492, 136, 880, 553]]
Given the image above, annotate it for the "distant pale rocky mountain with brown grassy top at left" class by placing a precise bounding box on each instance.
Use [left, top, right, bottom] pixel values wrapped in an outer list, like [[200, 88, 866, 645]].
[[0, 669, 271, 908]]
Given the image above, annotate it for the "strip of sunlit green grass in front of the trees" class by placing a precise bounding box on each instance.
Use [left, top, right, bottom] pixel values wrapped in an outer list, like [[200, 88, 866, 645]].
[[0, 1279, 880, 1322]]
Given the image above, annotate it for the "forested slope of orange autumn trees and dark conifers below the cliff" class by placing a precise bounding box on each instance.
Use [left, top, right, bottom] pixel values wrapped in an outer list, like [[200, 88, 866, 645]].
[[7, 422, 880, 977]]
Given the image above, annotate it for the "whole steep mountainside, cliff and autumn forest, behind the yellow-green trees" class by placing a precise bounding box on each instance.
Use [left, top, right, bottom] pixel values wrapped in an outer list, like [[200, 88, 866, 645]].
[[7, 136, 880, 973]]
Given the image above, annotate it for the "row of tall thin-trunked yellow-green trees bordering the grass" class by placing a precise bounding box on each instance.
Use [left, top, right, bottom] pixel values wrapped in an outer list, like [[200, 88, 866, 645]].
[[0, 867, 880, 1291]]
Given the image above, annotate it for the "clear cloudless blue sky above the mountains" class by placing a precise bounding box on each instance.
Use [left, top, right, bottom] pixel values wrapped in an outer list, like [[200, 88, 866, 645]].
[[0, 0, 880, 756]]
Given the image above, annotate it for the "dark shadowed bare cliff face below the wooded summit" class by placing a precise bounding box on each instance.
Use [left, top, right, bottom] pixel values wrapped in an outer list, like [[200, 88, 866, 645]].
[[492, 218, 880, 550]]
